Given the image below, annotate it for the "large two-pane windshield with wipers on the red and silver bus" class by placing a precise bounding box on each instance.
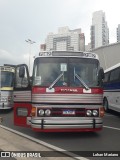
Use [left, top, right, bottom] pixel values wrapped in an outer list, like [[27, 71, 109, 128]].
[[33, 57, 99, 87]]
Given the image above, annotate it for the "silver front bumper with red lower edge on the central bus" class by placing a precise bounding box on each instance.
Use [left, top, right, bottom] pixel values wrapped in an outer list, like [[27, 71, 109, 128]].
[[27, 117, 103, 132]]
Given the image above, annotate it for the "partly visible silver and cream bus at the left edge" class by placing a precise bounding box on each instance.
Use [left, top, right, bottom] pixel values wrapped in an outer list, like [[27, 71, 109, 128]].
[[0, 64, 15, 110]]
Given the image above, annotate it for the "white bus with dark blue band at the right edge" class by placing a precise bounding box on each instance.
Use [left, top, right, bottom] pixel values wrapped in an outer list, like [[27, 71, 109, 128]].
[[103, 63, 120, 112]]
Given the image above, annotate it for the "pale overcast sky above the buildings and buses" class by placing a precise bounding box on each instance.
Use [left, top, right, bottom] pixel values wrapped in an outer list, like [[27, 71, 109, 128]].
[[0, 0, 120, 69]]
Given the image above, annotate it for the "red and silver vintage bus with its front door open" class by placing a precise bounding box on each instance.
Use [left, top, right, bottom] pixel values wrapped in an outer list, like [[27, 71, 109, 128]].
[[14, 51, 104, 132]]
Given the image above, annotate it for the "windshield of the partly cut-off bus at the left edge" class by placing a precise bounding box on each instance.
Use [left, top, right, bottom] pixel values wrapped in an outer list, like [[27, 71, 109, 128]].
[[0, 71, 14, 87]]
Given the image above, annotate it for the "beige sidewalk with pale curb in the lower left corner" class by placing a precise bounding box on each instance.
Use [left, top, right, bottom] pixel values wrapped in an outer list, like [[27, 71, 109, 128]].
[[0, 117, 84, 160]]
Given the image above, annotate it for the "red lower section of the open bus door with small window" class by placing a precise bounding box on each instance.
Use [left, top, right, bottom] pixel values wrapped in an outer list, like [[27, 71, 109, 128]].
[[14, 103, 32, 127]]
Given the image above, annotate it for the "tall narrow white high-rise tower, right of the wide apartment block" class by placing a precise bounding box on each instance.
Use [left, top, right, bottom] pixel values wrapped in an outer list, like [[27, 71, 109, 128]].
[[91, 10, 109, 49]]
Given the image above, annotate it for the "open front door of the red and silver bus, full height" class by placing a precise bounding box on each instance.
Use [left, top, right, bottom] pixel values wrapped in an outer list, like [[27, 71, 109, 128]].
[[14, 64, 32, 127]]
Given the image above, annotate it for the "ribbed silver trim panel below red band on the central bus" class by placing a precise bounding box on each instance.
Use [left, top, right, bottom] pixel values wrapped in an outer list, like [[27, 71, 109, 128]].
[[32, 94, 103, 103]]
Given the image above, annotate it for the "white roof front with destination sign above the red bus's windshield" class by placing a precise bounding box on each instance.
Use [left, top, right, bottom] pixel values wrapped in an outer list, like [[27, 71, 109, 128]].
[[39, 51, 98, 59]]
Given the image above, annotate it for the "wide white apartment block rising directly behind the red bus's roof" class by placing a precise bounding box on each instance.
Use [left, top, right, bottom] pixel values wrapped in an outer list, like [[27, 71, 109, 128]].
[[46, 27, 85, 51]]
